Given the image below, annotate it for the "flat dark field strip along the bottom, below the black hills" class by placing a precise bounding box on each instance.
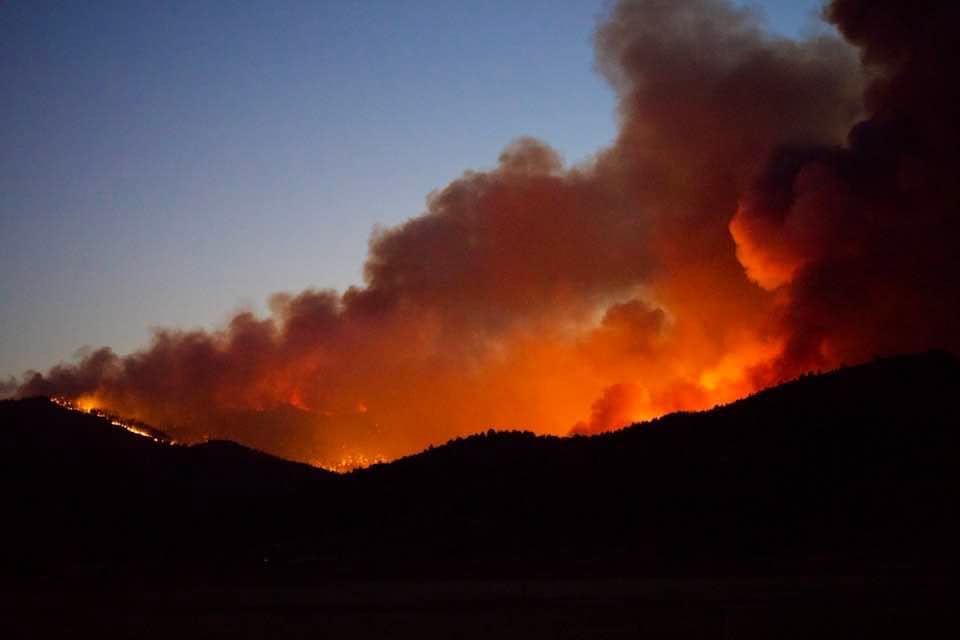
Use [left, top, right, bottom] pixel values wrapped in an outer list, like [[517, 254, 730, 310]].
[[0, 577, 960, 640]]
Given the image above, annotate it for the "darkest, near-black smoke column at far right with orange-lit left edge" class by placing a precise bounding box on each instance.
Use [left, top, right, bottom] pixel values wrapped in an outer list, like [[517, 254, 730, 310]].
[[731, 0, 960, 377]]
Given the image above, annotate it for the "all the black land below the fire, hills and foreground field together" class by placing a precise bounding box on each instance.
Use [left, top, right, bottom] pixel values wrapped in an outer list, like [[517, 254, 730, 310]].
[[0, 352, 960, 638]]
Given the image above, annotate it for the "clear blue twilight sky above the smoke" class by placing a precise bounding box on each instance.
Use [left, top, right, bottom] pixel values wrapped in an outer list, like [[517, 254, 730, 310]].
[[0, 0, 819, 381]]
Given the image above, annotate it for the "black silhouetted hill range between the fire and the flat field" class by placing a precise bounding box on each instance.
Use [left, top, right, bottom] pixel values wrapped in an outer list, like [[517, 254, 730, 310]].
[[0, 352, 960, 580]]
